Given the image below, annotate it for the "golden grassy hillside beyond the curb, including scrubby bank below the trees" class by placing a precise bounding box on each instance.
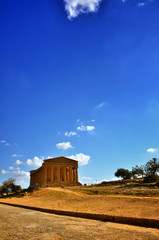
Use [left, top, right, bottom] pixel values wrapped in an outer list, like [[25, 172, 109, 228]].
[[1, 187, 159, 219]]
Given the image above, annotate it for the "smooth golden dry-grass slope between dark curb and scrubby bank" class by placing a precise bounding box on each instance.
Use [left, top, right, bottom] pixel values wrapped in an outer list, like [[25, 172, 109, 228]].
[[0, 188, 159, 219]]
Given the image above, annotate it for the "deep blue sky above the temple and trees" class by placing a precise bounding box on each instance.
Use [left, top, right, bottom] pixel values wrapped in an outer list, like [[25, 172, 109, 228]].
[[0, 0, 159, 186]]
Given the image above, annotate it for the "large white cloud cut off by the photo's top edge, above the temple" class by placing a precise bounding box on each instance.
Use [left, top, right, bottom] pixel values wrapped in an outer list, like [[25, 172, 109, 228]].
[[64, 0, 102, 19]]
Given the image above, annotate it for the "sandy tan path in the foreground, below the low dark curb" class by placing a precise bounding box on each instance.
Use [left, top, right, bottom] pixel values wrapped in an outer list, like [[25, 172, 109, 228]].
[[0, 204, 159, 240]]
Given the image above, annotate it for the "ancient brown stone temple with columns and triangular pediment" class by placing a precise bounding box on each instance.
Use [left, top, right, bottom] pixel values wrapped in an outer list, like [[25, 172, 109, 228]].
[[30, 157, 80, 187]]
